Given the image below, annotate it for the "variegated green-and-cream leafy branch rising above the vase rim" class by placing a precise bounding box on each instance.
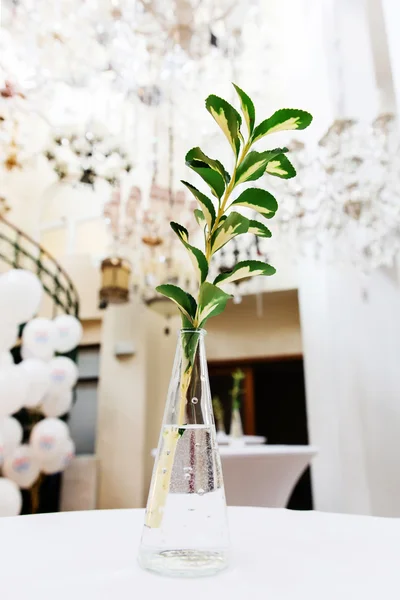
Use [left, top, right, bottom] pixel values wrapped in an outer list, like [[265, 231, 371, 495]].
[[157, 85, 312, 330]]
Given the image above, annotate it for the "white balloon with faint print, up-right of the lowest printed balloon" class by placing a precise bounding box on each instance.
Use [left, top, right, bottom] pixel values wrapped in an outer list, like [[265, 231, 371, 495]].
[[30, 418, 70, 462]]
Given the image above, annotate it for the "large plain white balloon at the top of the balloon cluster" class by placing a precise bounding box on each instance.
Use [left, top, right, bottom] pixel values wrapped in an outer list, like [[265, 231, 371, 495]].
[[0, 269, 43, 325]]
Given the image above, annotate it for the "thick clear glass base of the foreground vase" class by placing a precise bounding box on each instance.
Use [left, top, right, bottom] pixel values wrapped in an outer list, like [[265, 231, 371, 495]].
[[139, 549, 228, 577]]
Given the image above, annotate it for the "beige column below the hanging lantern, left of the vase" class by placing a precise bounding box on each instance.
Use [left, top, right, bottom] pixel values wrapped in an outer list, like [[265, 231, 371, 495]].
[[96, 302, 146, 508]]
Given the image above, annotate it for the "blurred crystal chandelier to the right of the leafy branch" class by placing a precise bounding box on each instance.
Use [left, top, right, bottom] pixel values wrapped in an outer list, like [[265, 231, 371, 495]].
[[266, 114, 400, 270]]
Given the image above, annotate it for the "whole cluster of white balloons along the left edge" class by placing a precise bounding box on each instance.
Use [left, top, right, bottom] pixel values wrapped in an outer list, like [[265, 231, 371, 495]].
[[0, 269, 82, 517]]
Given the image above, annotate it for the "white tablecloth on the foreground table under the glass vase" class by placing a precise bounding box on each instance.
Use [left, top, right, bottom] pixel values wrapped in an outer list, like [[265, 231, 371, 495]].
[[0, 508, 400, 600]]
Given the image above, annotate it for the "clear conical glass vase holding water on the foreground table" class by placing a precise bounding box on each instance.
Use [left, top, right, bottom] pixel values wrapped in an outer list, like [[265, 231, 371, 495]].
[[139, 329, 229, 577]]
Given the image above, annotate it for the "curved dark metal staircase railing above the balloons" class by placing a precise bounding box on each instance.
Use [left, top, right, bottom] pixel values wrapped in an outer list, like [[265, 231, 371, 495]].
[[0, 217, 79, 317]]
